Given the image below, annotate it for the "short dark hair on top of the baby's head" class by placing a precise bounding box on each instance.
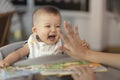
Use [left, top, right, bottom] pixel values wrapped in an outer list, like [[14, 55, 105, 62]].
[[33, 5, 61, 26]]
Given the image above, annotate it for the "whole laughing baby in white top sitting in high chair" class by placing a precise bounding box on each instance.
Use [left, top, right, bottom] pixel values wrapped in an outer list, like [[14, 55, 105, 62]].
[[0, 6, 89, 67]]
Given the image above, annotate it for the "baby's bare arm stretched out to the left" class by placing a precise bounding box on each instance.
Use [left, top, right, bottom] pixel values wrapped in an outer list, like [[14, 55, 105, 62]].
[[0, 44, 29, 67]]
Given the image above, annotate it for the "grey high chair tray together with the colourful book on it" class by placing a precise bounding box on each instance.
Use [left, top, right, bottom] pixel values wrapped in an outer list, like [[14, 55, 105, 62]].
[[0, 55, 107, 79]]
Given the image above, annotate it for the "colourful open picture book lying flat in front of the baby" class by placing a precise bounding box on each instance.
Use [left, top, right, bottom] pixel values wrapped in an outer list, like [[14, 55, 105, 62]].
[[3, 61, 107, 75]]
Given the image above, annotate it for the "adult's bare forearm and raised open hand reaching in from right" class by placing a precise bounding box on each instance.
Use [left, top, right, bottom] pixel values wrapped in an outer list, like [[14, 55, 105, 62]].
[[59, 22, 120, 69]]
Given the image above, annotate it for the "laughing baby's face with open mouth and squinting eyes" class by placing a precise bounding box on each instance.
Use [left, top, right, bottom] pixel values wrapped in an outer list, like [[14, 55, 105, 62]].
[[33, 13, 61, 44]]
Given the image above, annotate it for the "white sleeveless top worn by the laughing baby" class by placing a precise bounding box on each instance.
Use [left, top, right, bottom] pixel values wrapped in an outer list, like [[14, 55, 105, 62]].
[[28, 34, 62, 58]]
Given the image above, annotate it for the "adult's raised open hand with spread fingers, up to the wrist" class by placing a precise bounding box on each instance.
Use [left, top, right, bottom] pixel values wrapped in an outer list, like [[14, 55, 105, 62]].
[[59, 22, 88, 60]]
